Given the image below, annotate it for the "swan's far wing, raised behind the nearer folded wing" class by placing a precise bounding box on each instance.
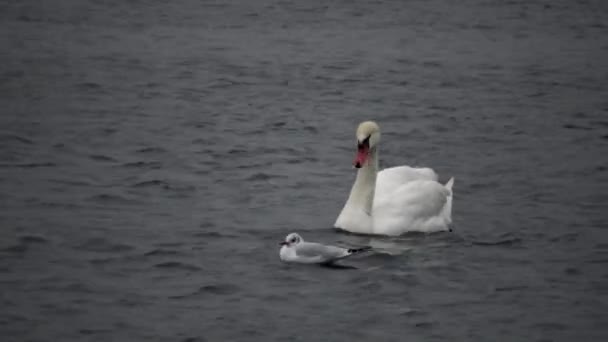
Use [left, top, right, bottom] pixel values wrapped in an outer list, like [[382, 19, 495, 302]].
[[374, 166, 437, 201]]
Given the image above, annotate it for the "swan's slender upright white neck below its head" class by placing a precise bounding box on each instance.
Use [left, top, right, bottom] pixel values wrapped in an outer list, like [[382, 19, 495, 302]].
[[346, 147, 378, 215]]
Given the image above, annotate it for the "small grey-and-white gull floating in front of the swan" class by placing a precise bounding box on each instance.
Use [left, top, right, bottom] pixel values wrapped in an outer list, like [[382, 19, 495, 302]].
[[280, 233, 371, 265]]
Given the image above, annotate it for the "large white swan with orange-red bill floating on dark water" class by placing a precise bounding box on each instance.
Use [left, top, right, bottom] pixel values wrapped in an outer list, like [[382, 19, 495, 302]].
[[334, 121, 454, 236]]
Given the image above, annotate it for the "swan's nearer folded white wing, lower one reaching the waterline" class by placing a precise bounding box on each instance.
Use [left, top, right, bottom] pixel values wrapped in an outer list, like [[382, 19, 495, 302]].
[[372, 180, 452, 235]]
